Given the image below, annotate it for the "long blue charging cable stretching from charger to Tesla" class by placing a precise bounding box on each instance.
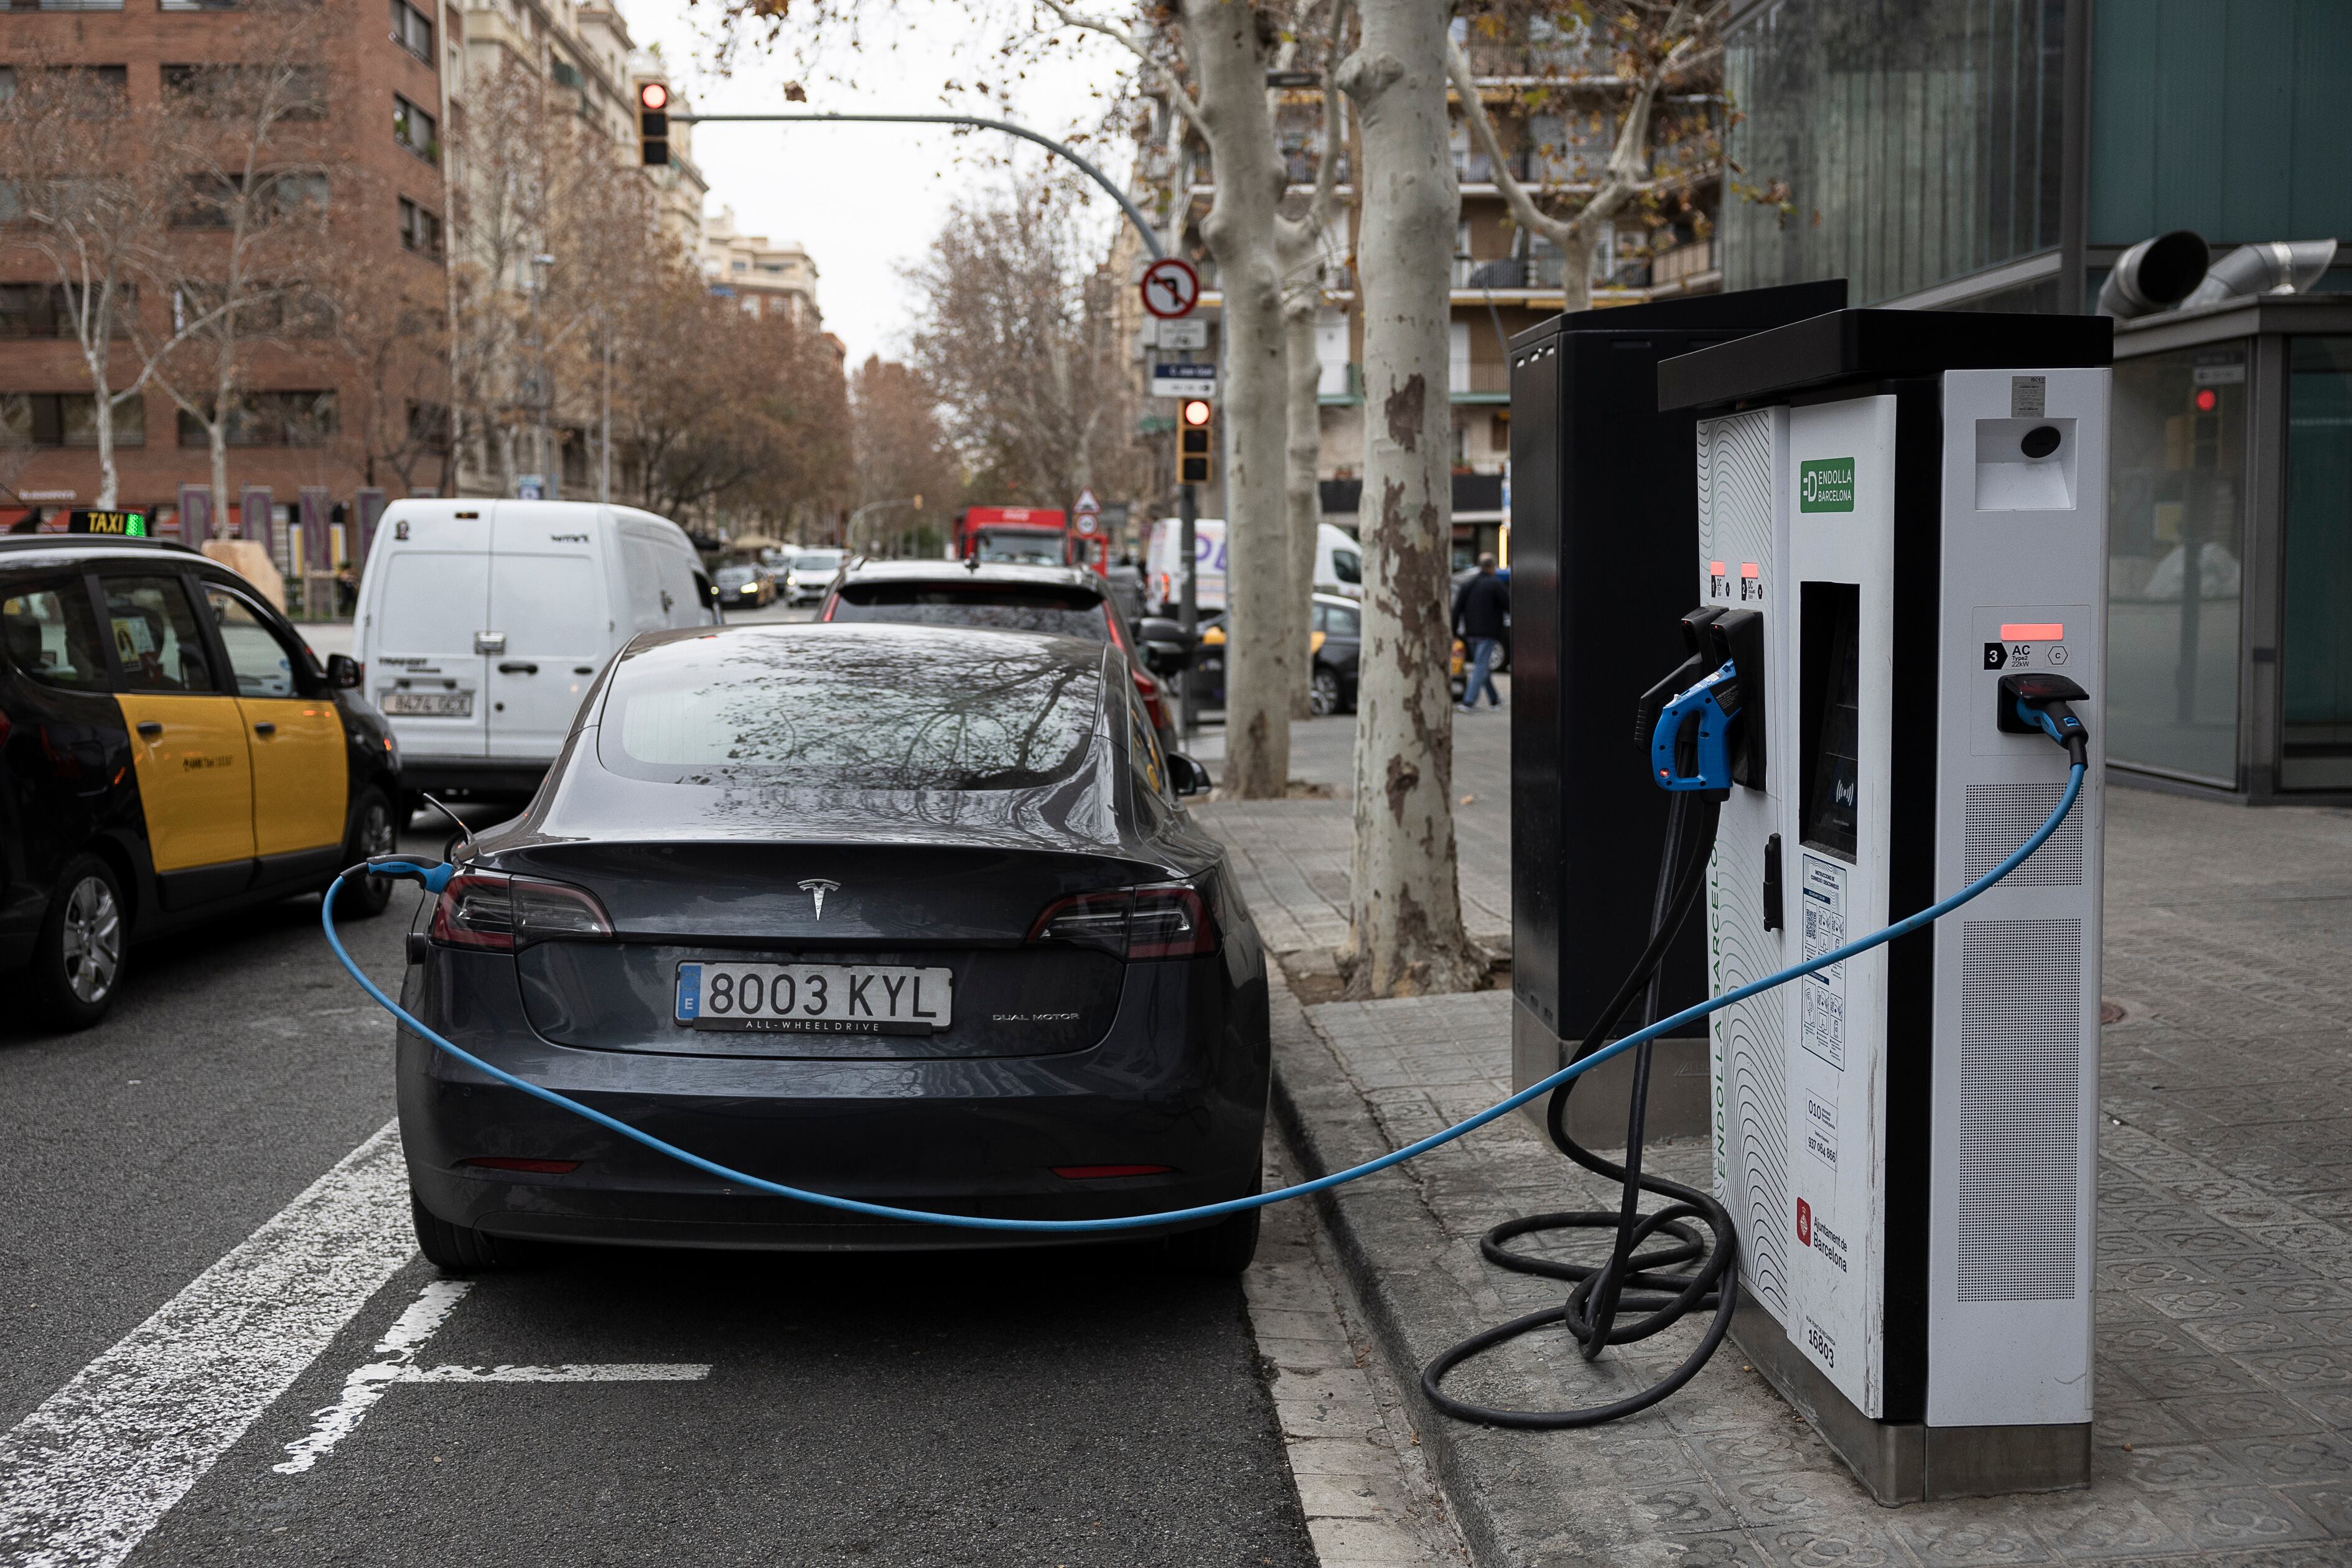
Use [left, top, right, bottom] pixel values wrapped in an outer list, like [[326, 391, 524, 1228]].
[[320, 762, 2086, 1234]]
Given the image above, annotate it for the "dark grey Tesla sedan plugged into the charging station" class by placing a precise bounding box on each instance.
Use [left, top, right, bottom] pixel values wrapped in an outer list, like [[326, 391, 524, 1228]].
[[400, 623, 1267, 1272]]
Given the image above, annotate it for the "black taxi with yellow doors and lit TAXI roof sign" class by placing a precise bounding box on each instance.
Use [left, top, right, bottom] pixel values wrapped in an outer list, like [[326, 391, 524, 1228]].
[[0, 534, 400, 1027]]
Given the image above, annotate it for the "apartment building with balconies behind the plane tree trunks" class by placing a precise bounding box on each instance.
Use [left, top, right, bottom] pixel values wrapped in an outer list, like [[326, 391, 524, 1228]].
[[1136, 24, 1722, 567]]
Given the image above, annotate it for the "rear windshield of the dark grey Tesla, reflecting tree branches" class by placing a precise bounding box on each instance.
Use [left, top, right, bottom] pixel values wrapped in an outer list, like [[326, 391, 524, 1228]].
[[597, 628, 1103, 790]]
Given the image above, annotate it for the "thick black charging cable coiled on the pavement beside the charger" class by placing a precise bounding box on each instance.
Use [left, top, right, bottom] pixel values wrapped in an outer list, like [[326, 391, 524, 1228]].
[[1421, 792, 1740, 1429]]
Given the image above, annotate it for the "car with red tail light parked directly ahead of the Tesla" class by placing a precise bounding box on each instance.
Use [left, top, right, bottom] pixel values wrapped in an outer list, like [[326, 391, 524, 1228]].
[[816, 562, 1181, 750]]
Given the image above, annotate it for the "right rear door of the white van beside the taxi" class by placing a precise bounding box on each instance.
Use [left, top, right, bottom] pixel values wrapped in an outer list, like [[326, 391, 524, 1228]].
[[487, 501, 612, 762]]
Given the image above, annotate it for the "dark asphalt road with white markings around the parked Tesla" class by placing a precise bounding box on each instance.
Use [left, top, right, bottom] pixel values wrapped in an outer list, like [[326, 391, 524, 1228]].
[[0, 691, 1315, 1568]]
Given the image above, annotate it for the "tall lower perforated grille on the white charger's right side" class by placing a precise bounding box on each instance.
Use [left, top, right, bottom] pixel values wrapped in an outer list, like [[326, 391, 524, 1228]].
[[1959, 922, 2081, 1302]]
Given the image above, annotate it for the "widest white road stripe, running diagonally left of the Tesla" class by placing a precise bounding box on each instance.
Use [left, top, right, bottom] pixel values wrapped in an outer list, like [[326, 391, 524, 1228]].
[[0, 1124, 416, 1568]]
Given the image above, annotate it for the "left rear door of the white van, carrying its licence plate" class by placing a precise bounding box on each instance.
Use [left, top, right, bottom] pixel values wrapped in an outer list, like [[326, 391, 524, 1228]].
[[362, 515, 497, 757]]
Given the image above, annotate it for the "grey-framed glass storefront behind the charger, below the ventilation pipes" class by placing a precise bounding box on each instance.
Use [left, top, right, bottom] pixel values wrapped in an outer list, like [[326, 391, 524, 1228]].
[[2107, 294, 2352, 804]]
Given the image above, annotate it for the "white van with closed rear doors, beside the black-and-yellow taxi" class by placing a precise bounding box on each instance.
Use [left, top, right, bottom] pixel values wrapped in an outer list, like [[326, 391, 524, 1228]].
[[355, 501, 720, 797]]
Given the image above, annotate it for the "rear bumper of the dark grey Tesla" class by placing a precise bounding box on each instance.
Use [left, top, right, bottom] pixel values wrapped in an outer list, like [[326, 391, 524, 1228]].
[[398, 950, 1267, 1251]]
